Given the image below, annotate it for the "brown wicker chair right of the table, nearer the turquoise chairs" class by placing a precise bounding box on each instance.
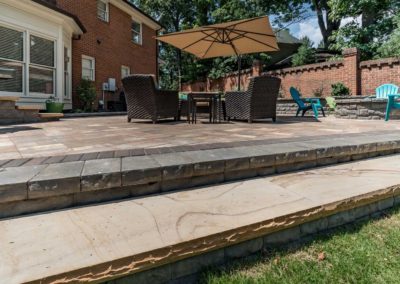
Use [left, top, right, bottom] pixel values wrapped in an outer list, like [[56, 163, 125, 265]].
[[225, 76, 281, 123]]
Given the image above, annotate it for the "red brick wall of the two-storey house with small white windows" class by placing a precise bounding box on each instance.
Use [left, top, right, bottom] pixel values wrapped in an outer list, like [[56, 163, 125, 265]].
[[57, 0, 157, 108]]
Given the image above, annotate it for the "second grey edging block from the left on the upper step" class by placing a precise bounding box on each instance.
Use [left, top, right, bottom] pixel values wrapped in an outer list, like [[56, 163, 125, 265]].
[[28, 161, 84, 199]]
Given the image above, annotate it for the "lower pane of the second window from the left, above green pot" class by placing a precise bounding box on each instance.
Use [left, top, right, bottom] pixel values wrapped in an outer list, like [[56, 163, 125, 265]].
[[29, 67, 54, 94]]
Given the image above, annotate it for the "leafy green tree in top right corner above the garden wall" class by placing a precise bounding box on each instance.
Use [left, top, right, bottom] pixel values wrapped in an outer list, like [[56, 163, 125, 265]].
[[328, 0, 400, 59]]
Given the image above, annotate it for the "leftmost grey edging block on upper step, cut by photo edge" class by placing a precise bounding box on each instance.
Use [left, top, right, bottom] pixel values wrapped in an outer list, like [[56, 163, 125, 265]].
[[0, 166, 46, 203]]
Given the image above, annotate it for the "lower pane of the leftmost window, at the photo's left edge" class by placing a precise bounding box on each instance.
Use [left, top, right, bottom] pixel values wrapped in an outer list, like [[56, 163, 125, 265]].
[[0, 60, 23, 93]]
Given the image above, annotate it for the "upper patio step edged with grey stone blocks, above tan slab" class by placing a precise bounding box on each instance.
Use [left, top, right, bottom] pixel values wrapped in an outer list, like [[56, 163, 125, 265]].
[[0, 134, 400, 218]]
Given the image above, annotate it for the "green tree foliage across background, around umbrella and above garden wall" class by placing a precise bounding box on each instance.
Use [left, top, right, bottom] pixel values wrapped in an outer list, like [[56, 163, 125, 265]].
[[134, 0, 400, 89]]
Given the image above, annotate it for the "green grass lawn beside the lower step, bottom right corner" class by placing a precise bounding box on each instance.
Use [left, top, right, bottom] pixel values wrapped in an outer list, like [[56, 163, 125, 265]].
[[202, 207, 400, 284]]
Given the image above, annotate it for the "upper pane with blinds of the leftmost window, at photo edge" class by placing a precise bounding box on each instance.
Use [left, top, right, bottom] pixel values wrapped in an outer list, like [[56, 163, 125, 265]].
[[0, 27, 24, 61]]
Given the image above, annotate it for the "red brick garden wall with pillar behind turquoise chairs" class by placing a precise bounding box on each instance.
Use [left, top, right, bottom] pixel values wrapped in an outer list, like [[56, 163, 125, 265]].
[[182, 49, 400, 98]]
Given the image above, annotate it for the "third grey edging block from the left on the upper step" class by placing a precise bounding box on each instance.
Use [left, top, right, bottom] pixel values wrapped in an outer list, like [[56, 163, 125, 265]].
[[81, 158, 121, 191]]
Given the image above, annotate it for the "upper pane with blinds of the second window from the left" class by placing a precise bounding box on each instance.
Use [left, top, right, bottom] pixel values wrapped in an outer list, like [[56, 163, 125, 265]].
[[30, 36, 54, 67]]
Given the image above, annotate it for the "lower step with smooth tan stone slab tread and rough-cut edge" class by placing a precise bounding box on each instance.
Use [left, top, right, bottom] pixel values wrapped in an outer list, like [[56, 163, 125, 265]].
[[0, 155, 400, 284]]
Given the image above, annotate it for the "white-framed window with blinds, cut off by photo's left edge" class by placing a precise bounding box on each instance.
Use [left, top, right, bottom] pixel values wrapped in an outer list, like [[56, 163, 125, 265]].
[[0, 26, 26, 93]]
